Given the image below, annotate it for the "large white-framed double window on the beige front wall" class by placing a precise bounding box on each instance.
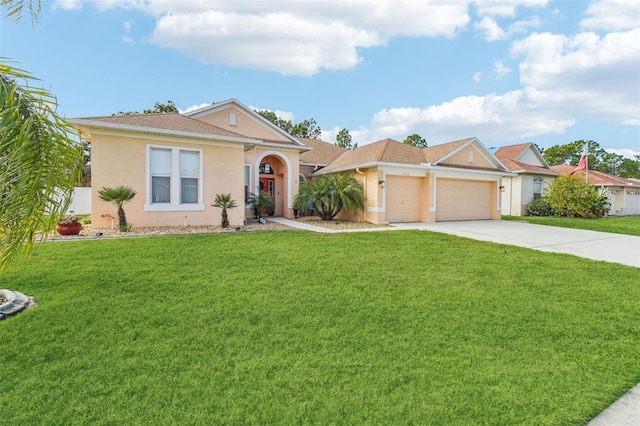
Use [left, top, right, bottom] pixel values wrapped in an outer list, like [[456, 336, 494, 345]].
[[145, 145, 204, 211]]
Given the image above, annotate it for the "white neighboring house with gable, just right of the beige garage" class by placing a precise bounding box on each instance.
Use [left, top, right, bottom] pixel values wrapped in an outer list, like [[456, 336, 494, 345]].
[[495, 142, 558, 216]]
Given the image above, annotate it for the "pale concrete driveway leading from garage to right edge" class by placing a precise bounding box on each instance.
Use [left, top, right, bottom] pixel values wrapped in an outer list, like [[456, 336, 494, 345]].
[[393, 220, 640, 268]]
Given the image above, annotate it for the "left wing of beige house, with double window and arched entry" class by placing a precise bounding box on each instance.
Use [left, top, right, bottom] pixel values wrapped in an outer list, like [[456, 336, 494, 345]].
[[69, 99, 310, 227]]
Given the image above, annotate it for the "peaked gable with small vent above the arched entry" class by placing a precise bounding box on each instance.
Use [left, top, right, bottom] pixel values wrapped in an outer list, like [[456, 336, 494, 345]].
[[185, 99, 304, 146]]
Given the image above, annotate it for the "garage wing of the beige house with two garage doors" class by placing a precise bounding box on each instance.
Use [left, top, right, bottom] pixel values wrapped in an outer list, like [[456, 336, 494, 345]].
[[314, 138, 509, 223]]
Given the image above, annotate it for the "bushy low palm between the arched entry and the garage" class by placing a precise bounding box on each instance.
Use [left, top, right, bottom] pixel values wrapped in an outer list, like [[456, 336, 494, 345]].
[[298, 173, 365, 220]]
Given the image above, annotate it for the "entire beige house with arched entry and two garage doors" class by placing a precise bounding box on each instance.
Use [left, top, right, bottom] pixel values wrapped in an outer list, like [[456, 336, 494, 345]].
[[69, 99, 511, 227]]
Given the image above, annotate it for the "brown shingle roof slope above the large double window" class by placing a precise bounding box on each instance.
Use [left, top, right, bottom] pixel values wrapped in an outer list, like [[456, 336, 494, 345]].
[[72, 112, 247, 138]]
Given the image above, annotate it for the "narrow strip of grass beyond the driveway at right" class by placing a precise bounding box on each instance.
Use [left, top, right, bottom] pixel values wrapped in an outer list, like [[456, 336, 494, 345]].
[[502, 216, 640, 236]]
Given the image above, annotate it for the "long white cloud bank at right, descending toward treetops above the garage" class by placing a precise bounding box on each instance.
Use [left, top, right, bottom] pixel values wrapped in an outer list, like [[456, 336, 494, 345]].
[[351, 29, 640, 145]]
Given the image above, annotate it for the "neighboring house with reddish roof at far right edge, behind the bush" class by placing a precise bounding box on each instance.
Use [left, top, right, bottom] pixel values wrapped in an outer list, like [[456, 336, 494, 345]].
[[551, 164, 640, 216]]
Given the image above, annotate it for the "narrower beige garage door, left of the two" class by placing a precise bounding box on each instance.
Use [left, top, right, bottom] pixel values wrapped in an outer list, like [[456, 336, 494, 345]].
[[386, 175, 422, 222]]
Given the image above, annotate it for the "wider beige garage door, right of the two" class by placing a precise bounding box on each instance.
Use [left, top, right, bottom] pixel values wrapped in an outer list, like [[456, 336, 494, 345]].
[[436, 179, 492, 222]]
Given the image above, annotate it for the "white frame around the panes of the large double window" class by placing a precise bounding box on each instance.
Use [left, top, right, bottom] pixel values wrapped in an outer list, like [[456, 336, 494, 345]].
[[144, 144, 205, 212]]
